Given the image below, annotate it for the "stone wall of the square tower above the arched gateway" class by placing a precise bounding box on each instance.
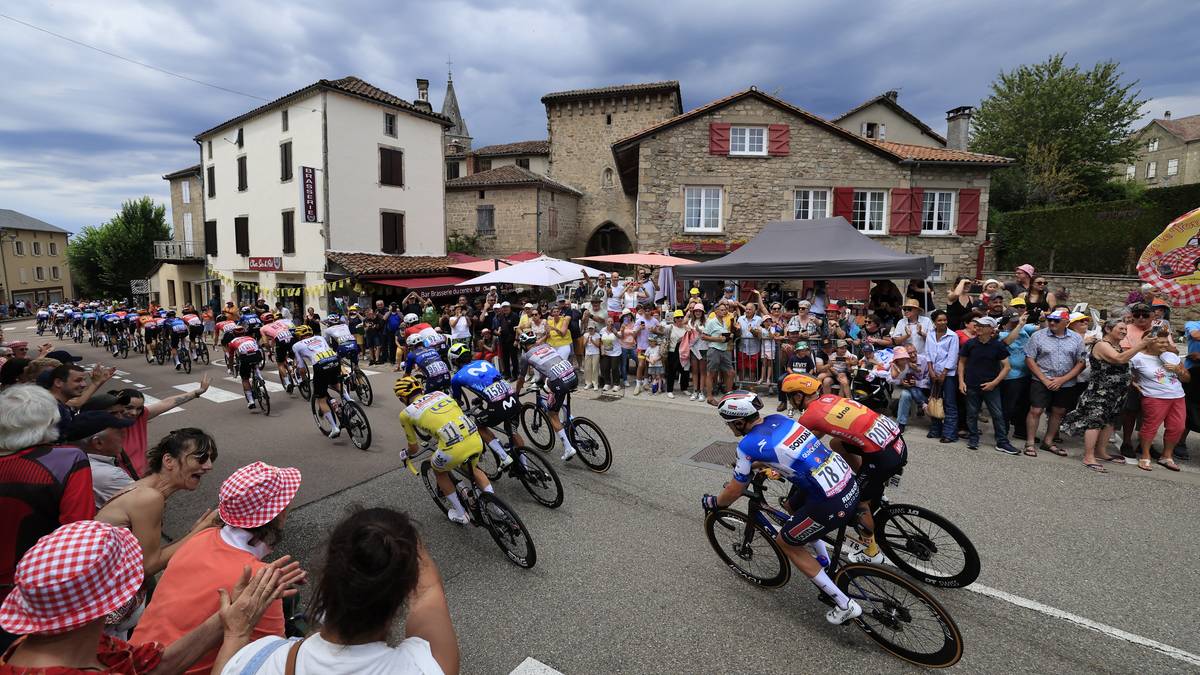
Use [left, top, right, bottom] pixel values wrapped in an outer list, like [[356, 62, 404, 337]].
[[546, 92, 680, 255]]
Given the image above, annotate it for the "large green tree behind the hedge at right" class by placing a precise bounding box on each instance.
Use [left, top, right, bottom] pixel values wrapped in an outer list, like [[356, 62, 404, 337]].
[[971, 54, 1146, 210]]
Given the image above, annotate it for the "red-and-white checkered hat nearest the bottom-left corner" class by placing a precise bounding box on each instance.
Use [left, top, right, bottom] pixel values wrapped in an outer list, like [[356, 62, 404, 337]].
[[0, 520, 143, 635]]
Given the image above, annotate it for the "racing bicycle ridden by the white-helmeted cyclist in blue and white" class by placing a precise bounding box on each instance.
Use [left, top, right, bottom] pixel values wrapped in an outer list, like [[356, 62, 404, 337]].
[[704, 471, 962, 668]]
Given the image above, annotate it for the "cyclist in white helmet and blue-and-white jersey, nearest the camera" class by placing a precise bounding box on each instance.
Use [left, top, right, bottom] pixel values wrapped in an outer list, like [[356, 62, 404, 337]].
[[701, 389, 863, 623]]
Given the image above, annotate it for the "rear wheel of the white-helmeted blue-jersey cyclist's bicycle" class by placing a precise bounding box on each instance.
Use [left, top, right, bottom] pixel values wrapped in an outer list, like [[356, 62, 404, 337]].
[[833, 565, 962, 668]]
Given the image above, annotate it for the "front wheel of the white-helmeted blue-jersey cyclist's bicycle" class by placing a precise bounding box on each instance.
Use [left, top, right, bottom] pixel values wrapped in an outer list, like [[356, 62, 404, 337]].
[[704, 508, 792, 589]]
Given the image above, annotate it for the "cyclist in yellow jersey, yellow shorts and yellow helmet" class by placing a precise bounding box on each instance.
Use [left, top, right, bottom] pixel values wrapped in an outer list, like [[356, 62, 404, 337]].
[[392, 375, 493, 525]]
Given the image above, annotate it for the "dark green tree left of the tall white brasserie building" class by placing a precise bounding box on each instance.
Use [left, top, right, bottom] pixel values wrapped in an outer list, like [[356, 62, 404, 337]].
[[67, 197, 170, 298]]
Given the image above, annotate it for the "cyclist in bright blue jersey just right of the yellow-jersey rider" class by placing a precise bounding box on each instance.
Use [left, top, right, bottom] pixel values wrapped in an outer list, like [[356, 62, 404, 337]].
[[450, 342, 513, 468]]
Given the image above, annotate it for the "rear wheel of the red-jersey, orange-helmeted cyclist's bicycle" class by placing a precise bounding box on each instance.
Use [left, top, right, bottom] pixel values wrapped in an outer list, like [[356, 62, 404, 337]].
[[875, 504, 979, 589]]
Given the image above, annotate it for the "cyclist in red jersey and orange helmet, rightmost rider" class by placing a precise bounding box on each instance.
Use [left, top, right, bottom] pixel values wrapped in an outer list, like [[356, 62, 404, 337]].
[[780, 374, 908, 565]]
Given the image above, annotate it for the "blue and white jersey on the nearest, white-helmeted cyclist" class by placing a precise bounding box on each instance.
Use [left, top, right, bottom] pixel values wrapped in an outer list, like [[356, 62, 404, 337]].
[[733, 414, 858, 509]]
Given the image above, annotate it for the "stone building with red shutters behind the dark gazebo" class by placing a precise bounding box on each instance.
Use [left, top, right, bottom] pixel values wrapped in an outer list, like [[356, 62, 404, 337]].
[[609, 88, 1010, 279]]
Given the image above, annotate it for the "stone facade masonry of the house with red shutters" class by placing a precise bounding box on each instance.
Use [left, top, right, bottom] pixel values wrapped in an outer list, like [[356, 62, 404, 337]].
[[637, 98, 990, 281]]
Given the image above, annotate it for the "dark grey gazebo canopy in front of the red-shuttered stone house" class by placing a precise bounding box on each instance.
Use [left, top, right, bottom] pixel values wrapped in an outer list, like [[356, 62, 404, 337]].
[[674, 216, 934, 281]]
